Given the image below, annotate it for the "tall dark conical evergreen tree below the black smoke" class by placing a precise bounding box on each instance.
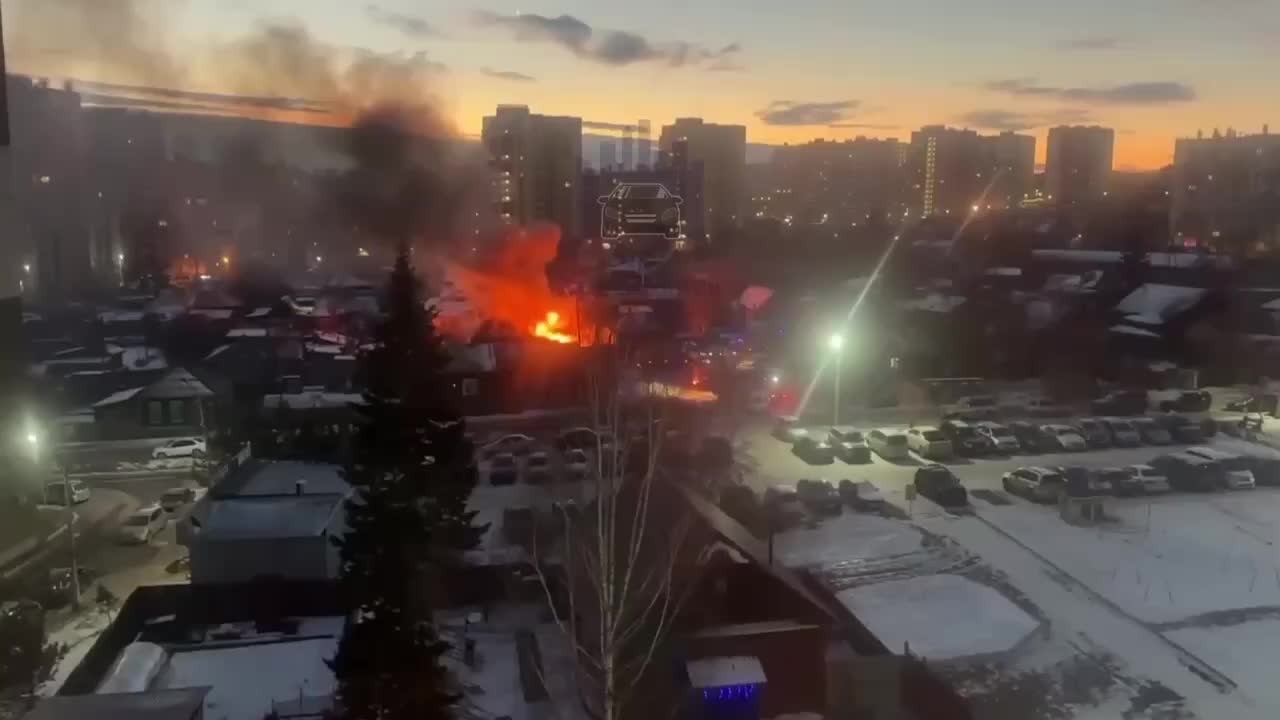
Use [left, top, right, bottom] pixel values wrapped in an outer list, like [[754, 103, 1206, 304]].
[[330, 247, 484, 720]]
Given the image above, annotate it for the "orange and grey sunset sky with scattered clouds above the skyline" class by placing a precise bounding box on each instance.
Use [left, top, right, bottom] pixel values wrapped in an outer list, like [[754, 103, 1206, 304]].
[[4, 0, 1280, 169]]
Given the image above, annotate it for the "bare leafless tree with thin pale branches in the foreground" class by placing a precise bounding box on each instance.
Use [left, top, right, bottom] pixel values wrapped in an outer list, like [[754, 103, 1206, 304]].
[[532, 346, 698, 720]]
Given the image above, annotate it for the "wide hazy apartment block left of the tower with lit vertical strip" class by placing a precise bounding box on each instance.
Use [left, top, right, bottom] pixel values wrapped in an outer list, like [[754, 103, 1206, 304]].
[[762, 137, 906, 225]]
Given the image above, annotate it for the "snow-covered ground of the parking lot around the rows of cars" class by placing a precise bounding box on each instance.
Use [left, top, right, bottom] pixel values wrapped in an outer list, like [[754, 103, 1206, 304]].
[[739, 424, 1280, 719]]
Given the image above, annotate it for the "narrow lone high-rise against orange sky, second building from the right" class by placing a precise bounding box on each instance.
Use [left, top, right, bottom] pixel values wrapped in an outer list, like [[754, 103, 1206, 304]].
[[1044, 126, 1116, 208]]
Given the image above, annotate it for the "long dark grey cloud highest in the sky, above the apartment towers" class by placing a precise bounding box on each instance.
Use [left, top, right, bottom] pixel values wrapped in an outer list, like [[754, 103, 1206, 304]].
[[472, 10, 742, 70]]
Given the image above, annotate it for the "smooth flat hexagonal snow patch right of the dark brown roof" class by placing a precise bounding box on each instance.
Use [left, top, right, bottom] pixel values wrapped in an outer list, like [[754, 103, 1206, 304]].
[[837, 574, 1039, 660]]
